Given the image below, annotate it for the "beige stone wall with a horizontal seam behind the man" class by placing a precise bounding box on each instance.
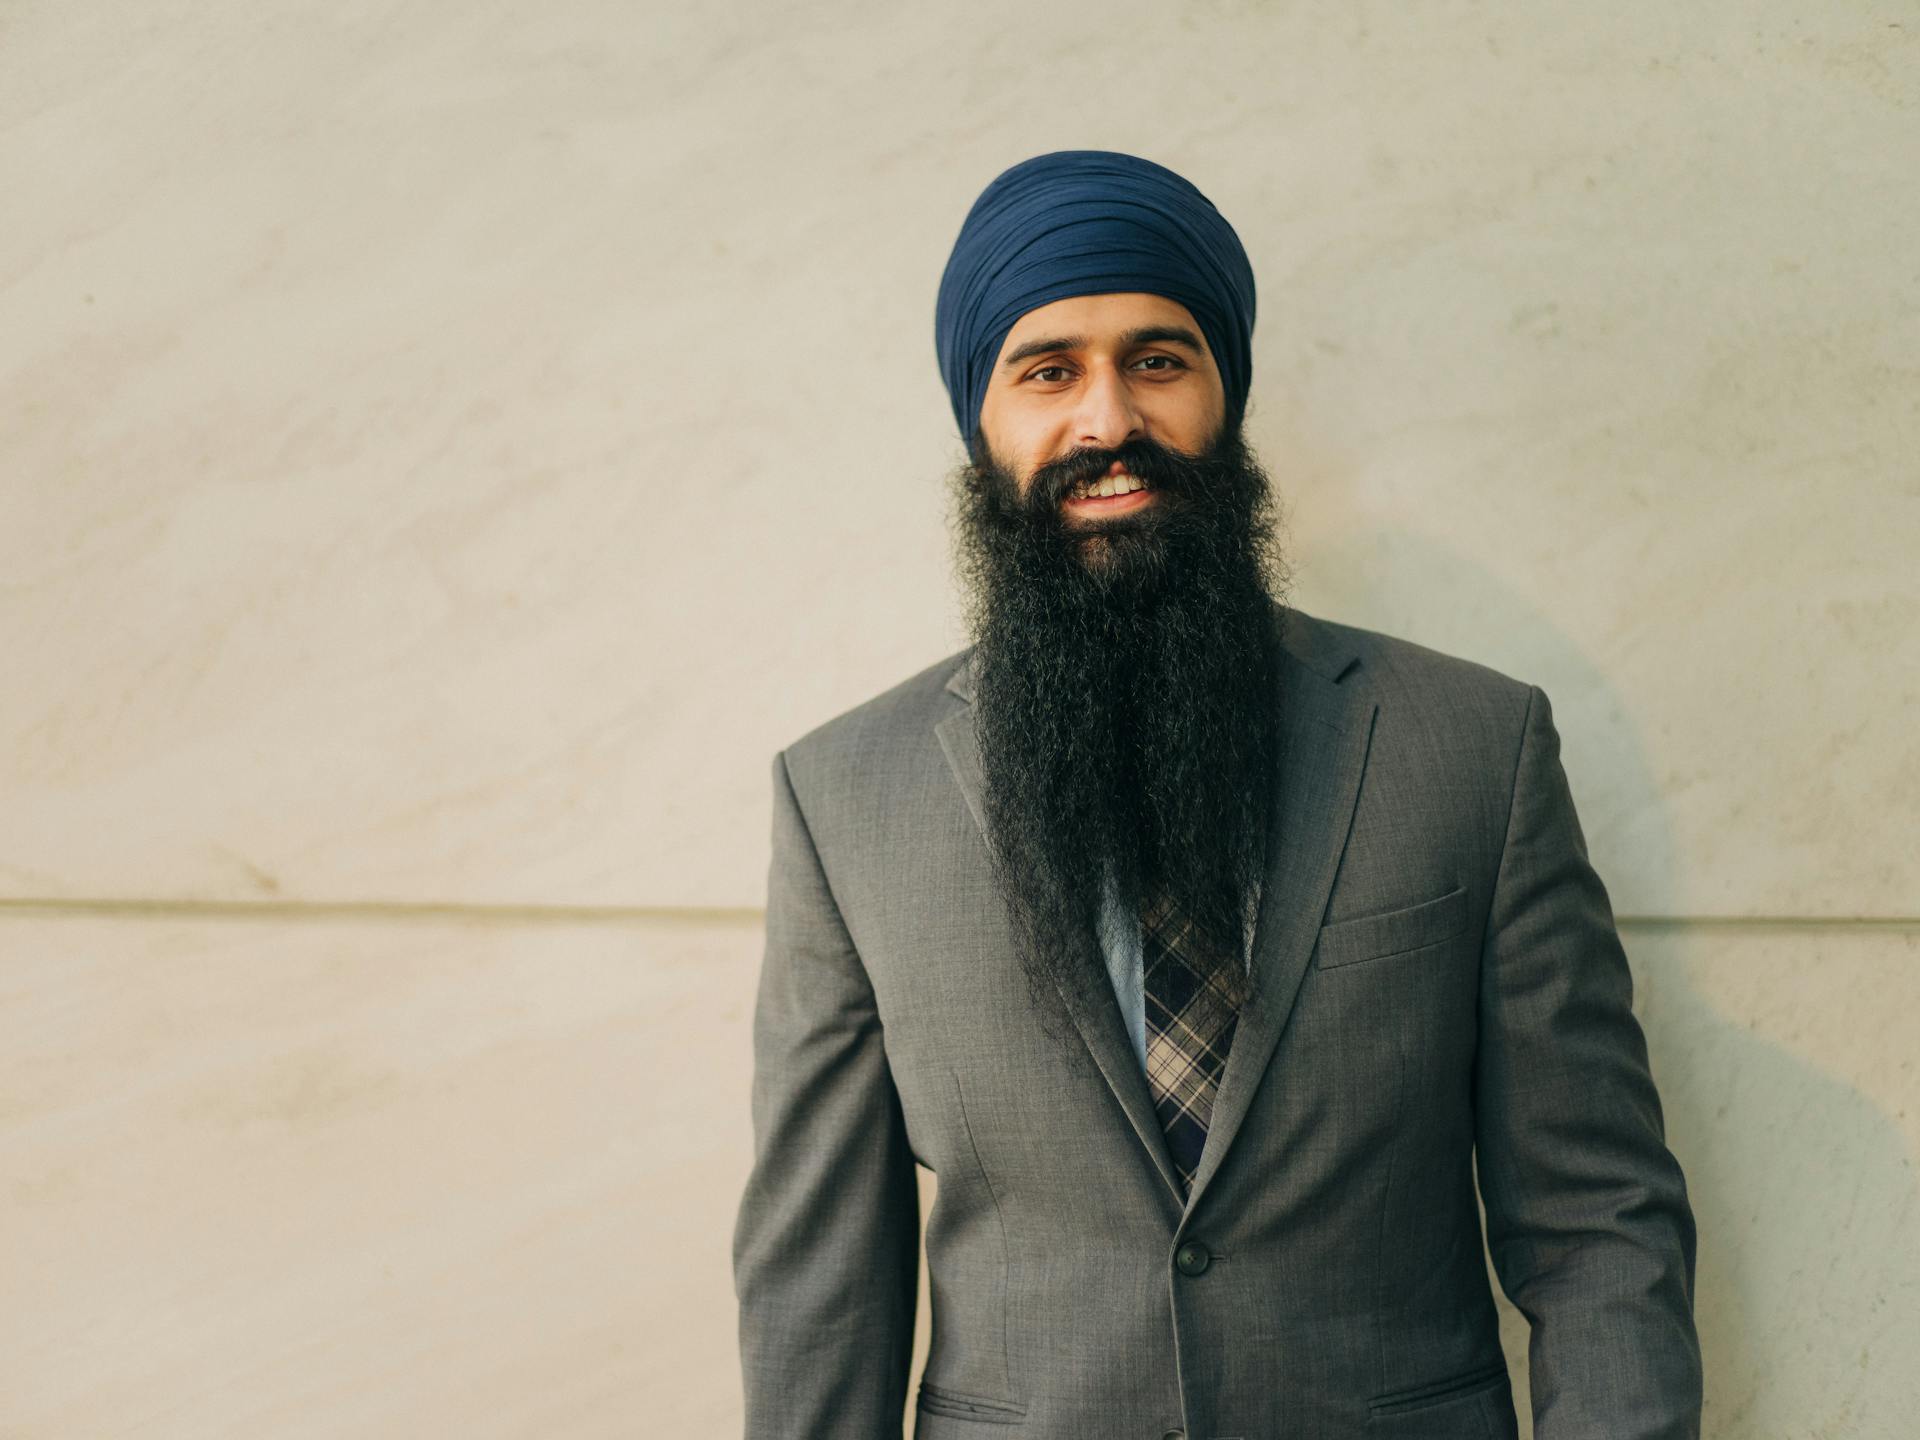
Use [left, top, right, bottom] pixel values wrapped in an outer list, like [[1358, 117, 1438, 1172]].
[[0, 0, 1920, 1440]]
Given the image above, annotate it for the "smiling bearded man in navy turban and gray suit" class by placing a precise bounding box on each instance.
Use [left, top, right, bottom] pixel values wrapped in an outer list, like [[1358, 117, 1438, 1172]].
[[733, 152, 1701, 1440]]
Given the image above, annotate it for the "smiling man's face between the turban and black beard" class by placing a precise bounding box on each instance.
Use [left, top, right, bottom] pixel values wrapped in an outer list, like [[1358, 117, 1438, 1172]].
[[979, 292, 1227, 522]]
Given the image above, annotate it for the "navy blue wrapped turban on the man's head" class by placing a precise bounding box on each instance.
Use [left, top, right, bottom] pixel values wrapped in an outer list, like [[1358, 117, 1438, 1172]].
[[933, 150, 1254, 444]]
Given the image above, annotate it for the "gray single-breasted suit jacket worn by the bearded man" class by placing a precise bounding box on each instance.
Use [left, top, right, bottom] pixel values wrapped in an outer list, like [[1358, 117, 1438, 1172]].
[[733, 607, 1701, 1440]]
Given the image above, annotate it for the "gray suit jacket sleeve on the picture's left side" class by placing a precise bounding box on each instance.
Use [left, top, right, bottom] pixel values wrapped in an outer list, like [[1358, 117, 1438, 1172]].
[[733, 751, 920, 1440]]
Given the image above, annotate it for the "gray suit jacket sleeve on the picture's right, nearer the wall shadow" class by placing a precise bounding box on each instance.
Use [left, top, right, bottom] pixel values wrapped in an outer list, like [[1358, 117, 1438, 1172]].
[[1475, 685, 1701, 1440]]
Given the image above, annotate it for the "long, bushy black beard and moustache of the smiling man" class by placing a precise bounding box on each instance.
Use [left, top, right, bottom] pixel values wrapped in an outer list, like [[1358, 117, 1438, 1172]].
[[952, 422, 1286, 1033]]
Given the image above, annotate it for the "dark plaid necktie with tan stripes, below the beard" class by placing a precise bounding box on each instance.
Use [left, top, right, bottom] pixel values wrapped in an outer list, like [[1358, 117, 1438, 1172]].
[[1140, 895, 1240, 1194]]
